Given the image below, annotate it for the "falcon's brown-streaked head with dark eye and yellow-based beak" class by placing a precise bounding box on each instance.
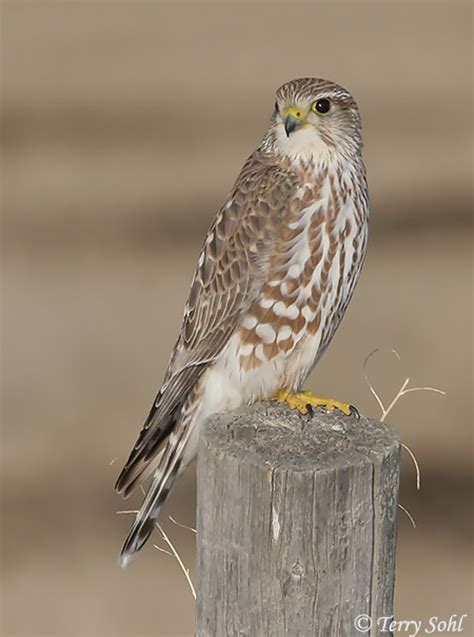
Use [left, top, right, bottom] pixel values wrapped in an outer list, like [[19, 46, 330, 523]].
[[266, 78, 362, 160]]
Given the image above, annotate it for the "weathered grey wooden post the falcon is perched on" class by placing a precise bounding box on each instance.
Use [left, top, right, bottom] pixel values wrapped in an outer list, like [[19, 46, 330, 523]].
[[196, 402, 399, 637]]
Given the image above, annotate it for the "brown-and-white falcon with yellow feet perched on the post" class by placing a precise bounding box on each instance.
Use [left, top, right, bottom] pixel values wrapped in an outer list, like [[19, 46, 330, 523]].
[[115, 77, 370, 567]]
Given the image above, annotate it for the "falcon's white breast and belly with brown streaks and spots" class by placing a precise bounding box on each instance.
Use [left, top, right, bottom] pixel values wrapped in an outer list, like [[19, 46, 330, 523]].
[[238, 166, 367, 384]]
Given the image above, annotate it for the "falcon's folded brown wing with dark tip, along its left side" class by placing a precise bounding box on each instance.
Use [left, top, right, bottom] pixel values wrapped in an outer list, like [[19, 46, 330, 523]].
[[116, 151, 295, 495]]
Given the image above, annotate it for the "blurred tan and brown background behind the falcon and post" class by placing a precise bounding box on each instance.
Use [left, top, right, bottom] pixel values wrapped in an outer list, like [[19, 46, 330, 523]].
[[1, 0, 474, 637]]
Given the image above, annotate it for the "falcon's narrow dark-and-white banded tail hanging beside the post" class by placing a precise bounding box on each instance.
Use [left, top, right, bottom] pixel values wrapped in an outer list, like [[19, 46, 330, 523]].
[[118, 446, 181, 568]]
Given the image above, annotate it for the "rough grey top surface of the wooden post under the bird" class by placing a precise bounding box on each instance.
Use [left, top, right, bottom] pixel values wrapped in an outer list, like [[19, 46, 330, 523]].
[[201, 401, 400, 471]]
